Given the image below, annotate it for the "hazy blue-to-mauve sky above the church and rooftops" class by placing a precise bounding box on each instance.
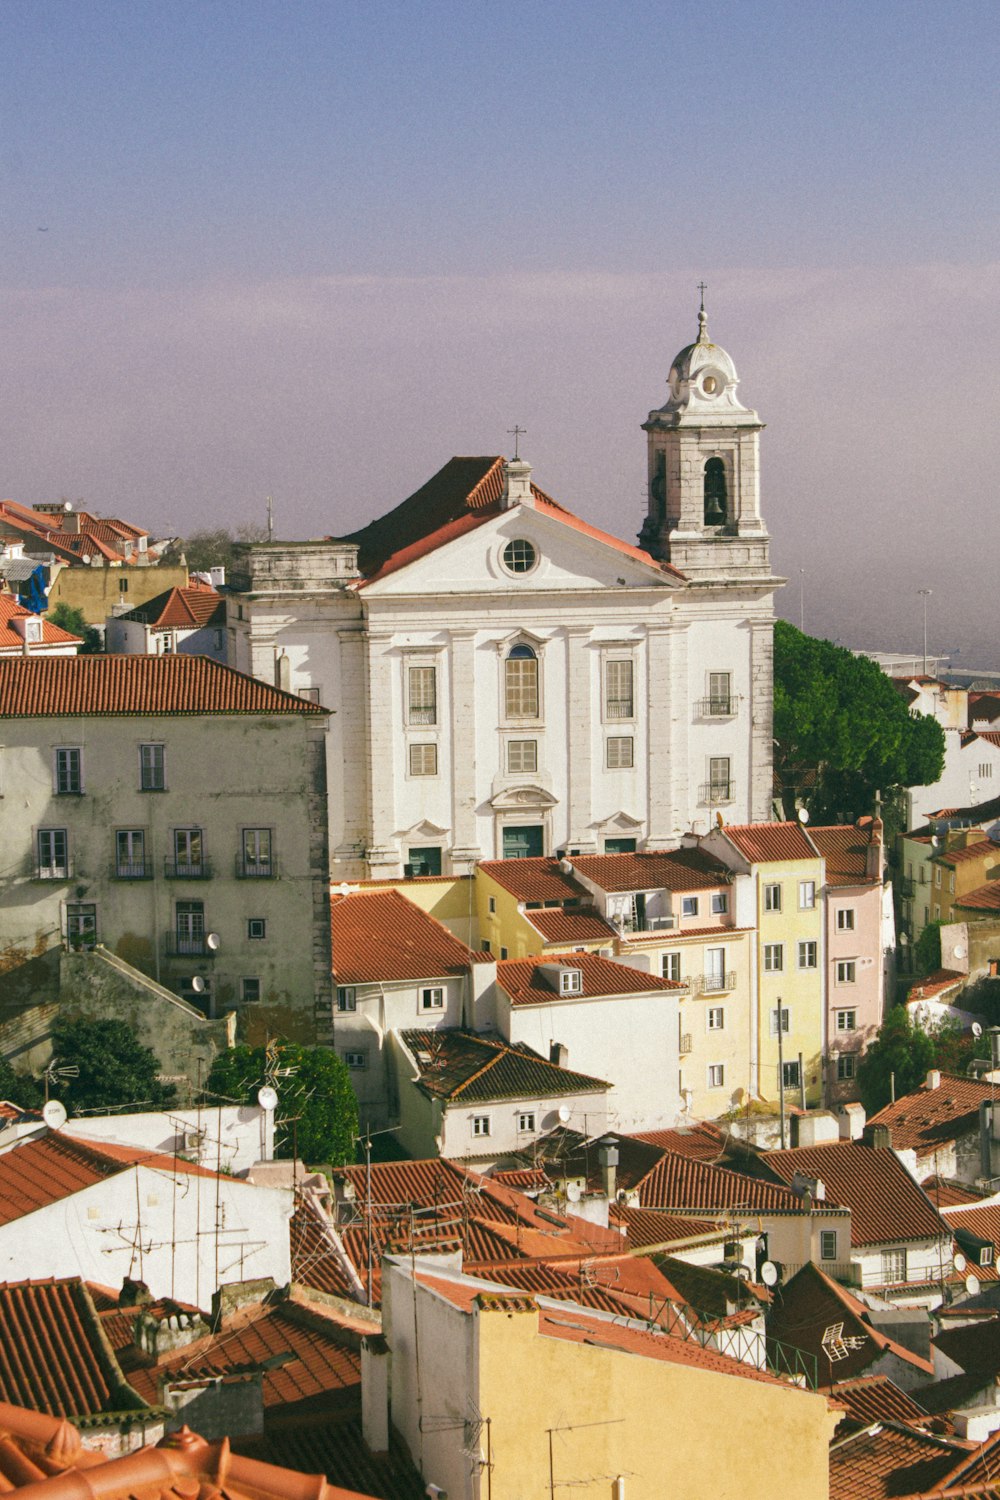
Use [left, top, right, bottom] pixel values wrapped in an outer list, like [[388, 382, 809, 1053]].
[[0, 0, 1000, 668]]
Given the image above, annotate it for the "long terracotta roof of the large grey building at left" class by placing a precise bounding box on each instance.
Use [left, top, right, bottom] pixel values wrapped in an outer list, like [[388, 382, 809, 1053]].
[[0, 656, 327, 719]]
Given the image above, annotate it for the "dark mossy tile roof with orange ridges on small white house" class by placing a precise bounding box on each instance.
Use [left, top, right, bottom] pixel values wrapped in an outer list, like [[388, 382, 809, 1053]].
[[402, 1028, 612, 1104]]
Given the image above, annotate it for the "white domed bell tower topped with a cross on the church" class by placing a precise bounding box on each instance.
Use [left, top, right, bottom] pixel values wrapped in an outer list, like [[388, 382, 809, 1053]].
[[639, 287, 771, 582]]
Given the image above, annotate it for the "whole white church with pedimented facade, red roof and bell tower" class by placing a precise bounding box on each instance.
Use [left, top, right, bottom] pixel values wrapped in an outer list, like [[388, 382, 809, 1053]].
[[228, 311, 780, 881]]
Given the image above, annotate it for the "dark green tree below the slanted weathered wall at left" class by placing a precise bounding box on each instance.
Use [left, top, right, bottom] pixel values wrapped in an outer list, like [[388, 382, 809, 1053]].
[[49, 1019, 177, 1113]]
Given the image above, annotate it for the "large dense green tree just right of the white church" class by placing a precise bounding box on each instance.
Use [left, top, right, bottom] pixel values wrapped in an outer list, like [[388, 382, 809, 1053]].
[[774, 620, 945, 822]]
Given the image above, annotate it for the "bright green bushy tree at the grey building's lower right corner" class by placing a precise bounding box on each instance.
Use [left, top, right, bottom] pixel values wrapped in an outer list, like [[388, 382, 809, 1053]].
[[205, 1043, 358, 1167]]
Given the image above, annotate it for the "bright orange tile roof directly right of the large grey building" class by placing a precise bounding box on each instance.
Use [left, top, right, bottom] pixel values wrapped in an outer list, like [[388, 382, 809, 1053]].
[[330, 891, 475, 984]]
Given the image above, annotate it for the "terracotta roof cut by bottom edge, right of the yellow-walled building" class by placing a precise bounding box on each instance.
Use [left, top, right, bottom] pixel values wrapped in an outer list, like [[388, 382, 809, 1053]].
[[829, 1422, 960, 1500]]
